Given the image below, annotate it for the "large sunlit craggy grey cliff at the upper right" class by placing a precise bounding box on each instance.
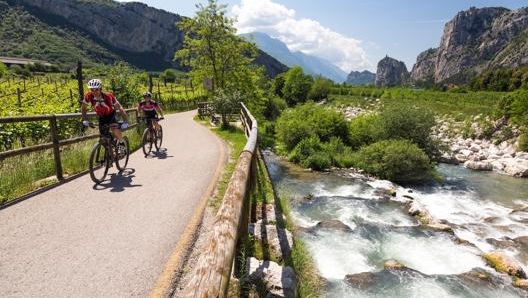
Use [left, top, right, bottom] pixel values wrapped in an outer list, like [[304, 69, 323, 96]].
[[411, 7, 528, 83]]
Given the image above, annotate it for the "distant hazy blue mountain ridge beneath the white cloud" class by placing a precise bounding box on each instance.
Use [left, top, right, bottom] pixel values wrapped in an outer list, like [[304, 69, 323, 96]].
[[241, 32, 347, 83]]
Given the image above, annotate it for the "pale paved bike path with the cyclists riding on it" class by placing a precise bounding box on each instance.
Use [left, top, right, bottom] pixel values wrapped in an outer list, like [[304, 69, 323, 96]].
[[0, 111, 225, 298]]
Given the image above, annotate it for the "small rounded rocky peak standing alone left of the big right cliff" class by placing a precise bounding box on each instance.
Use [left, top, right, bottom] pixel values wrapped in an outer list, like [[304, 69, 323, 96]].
[[376, 56, 409, 87]]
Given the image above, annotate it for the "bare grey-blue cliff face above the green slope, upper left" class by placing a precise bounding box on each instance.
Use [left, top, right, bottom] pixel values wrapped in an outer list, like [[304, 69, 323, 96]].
[[8, 0, 183, 66]]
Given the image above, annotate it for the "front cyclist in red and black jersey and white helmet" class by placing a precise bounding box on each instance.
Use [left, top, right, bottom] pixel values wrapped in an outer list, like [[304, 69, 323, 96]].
[[81, 79, 128, 148]]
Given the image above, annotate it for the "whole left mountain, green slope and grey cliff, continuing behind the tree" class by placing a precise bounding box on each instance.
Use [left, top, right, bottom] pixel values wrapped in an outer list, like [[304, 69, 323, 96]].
[[0, 0, 287, 77]]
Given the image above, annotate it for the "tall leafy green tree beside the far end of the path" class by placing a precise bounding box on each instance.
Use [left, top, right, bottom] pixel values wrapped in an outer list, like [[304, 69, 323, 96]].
[[175, 0, 258, 94]]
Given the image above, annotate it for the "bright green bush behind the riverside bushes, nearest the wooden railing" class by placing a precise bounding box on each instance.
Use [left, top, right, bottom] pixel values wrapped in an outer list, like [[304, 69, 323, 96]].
[[275, 102, 348, 151]]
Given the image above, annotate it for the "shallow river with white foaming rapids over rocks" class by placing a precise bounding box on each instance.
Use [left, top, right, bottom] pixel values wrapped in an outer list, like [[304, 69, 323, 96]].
[[266, 154, 528, 298]]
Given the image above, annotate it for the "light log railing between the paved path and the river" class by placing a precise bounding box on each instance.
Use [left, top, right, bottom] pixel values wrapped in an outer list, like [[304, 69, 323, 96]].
[[181, 104, 257, 298]]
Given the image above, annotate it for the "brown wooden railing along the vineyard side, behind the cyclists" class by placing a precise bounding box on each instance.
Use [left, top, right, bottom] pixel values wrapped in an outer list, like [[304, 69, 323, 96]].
[[0, 109, 138, 181]]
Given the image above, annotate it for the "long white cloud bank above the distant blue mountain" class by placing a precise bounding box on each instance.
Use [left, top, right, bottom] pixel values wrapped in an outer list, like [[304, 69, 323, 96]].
[[231, 0, 375, 73]]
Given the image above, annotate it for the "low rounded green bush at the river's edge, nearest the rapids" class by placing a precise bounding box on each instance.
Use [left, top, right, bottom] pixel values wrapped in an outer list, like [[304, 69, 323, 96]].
[[354, 139, 434, 185]]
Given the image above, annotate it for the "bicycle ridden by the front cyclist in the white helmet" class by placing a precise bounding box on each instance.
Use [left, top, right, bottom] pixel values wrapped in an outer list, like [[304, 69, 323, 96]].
[[89, 121, 130, 184]]
